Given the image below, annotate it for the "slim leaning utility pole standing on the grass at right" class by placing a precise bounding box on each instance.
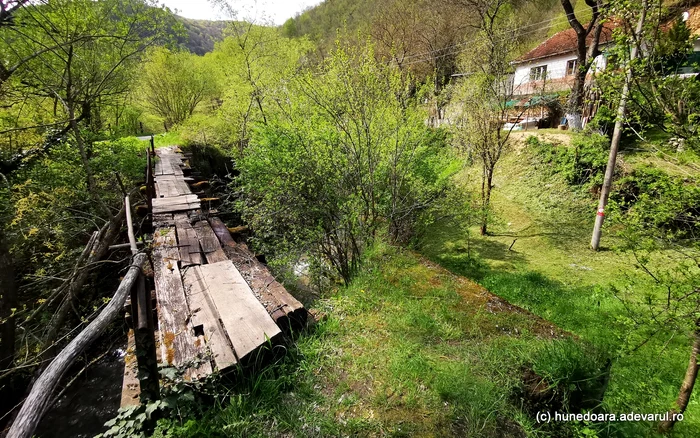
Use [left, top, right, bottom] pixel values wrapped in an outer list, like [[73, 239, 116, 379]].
[[591, 0, 649, 251]]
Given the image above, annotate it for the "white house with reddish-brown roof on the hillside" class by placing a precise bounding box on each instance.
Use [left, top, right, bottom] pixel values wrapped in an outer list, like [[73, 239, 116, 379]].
[[513, 25, 612, 96]]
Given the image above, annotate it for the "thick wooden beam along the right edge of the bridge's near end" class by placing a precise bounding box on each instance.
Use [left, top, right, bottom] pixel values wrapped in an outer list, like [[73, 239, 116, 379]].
[[209, 217, 308, 330]]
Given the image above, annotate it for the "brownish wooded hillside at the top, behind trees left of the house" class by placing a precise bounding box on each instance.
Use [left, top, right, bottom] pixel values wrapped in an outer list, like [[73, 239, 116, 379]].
[[281, 0, 564, 84]]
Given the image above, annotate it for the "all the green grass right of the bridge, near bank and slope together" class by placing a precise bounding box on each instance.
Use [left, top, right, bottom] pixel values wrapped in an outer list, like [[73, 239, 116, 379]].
[[146, 131, 700, 437]]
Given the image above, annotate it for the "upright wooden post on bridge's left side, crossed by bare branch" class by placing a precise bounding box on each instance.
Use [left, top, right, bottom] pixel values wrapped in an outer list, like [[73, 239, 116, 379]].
[[124, 196, 160, 403]]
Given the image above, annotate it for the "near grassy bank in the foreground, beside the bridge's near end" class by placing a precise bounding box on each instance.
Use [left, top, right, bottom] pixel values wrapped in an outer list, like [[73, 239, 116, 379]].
[[150, 241, 599, 437]]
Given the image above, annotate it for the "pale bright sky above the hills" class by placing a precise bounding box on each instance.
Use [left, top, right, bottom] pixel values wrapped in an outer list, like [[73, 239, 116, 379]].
[[159, 0, 322, 25]]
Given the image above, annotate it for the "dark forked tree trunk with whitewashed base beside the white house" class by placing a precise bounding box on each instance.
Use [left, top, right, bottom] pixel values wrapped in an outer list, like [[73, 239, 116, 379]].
[[561, 0, 603, 130]]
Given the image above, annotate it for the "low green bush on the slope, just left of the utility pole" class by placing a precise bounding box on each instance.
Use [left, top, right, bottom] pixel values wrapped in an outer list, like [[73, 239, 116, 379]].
[[527, 134, 610, 187]]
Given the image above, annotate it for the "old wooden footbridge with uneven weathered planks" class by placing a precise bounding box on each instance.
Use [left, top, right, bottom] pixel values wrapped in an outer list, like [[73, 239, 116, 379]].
[[122, 147, 307, 406]]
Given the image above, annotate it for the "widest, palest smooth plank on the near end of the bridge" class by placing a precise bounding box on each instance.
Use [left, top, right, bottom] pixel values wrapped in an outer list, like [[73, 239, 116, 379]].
[[199, 260, 281, 360]]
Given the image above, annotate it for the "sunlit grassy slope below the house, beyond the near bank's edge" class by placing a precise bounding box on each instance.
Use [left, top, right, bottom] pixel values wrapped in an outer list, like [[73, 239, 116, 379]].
[[422, 132, 700, 436]]
